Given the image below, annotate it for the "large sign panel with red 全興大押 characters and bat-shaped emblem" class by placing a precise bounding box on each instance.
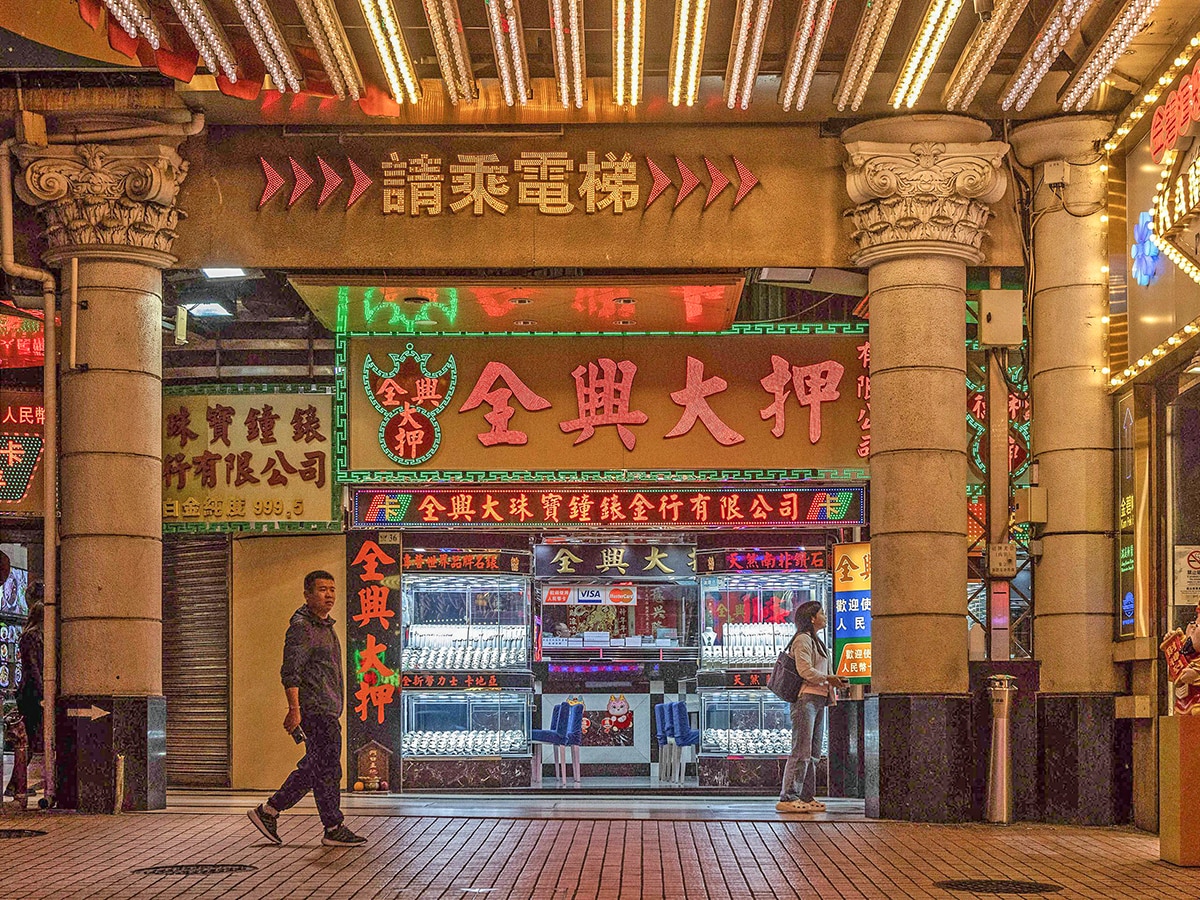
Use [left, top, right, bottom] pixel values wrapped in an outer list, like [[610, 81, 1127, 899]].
[[344, 326, 870, 478]]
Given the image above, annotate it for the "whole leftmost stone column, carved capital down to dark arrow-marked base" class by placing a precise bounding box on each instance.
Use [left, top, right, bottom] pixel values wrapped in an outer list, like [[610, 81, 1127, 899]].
[[17, 143, 187, 811]]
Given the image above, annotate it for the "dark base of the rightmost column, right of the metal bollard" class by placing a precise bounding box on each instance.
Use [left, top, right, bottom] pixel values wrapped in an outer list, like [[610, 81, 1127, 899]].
[[1038, 694, 1133, 826]]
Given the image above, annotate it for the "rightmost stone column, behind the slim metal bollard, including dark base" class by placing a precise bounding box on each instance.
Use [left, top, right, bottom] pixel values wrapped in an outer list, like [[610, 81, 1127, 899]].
[[1012, 116, 1128, 824]]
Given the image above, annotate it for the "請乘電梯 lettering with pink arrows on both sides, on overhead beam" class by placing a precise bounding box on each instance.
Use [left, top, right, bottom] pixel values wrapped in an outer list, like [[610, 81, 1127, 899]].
[[258, 150, 761, 218]]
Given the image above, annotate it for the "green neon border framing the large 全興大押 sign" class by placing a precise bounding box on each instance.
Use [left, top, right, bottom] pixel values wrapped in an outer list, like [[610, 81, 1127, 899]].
[[334, 322, 868, 485]]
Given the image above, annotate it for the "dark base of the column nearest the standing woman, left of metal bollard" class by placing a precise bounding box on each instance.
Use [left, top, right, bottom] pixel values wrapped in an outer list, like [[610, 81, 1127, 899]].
[[864, 694, 974, 822]]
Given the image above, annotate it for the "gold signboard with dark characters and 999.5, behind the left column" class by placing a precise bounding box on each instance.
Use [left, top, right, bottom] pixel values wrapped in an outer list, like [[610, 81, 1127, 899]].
[[162, 391, 340, 530]]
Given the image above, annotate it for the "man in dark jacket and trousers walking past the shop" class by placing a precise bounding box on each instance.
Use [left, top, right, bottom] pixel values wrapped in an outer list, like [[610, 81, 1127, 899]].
[[246, 569, 366, 847]]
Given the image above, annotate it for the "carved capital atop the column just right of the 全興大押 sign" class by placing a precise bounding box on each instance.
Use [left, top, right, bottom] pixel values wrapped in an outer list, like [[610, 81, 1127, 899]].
[[846, 140, 1008, 265]]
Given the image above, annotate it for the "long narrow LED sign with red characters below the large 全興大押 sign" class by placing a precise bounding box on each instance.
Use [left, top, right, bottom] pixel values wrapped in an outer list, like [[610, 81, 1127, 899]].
[[352, 484, 866, 529]]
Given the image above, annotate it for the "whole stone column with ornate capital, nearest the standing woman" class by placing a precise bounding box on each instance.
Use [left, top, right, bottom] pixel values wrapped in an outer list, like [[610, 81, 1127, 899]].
[[842, 115, 1008, 822]]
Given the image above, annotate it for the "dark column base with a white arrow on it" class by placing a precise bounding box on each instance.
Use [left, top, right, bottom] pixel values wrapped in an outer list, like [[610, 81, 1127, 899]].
[[58, 694, 167, 812]]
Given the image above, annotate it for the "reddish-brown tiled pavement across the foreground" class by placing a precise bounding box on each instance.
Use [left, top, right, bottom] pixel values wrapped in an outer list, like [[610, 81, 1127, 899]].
[[0, 794, 1200, 900]]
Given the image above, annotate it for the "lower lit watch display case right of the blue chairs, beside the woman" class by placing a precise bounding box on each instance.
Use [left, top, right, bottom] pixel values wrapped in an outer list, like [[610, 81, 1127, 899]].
[[700, 690, 792, 756]]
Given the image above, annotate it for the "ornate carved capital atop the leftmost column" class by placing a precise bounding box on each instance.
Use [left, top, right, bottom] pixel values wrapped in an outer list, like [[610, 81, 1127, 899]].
[[17, 144, 187, 259]]
